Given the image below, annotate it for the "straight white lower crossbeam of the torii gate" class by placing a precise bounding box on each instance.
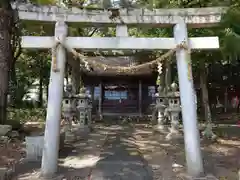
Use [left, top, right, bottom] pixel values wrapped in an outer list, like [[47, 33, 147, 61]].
[[22, 36, 219, 50]]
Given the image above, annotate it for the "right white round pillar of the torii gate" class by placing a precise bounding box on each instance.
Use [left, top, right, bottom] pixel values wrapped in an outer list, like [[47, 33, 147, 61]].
[[174, 20, 203, 177]]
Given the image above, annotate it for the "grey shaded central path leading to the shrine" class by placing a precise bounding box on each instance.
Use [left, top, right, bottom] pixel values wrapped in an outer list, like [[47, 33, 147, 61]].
[[87, 125, 153, 180]]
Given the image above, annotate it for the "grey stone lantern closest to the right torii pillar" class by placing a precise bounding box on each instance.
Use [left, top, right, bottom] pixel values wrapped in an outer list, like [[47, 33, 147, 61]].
[[166, 83, 181, 139]]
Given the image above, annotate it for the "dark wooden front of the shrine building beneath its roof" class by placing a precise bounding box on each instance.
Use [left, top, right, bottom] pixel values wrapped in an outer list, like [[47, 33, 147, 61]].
[[82, 73, 157, 116]]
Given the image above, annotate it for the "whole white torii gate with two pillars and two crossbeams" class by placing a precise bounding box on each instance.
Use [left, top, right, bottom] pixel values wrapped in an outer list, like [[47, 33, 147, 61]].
[[13, 4, 225, 177]]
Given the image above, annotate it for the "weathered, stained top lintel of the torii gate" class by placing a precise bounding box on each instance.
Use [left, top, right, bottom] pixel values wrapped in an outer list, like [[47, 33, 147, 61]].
[[12, 3, 226, 28]]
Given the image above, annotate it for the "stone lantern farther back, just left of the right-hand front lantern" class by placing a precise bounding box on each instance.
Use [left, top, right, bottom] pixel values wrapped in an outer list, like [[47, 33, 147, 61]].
[[155, 85, 166, 131]]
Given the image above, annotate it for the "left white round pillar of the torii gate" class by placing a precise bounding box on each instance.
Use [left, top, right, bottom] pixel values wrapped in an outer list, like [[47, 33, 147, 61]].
[[41, 22, 67, 178]]
